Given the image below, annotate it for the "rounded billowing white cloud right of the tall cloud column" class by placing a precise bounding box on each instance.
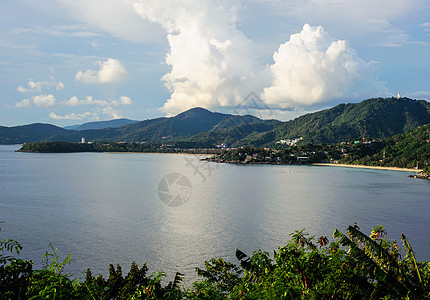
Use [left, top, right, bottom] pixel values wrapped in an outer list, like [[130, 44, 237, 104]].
[[262, 24, 386, 108]]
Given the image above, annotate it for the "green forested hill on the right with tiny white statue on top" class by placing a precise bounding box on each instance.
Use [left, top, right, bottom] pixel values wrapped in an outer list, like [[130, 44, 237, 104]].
[[242, 98, 430, 146]]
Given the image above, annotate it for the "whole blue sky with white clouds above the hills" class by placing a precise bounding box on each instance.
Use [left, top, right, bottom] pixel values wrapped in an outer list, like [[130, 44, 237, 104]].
[[0, 0, 430, 126]]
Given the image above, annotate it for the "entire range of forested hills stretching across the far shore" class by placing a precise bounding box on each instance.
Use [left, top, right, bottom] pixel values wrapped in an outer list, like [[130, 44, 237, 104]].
[[0, 98, 430, 148]]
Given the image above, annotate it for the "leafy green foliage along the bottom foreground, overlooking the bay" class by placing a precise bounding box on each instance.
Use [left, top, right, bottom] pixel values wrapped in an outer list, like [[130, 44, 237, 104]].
[[0, 221, 430, 299]]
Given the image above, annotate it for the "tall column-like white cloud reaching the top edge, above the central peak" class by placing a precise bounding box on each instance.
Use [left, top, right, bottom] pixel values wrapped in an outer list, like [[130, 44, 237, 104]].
[[127, 0, 264, 114]]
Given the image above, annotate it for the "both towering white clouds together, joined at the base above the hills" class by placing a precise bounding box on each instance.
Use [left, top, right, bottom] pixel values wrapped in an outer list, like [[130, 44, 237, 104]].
[[126, 0, 386, 114]]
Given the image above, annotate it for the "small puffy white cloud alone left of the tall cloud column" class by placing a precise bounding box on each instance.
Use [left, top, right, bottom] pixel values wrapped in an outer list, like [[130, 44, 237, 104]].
[[75, 58, 128, 84]]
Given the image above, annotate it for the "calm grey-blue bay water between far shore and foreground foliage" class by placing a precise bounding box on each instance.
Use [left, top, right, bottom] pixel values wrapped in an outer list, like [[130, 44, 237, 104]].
[[0, 145, 430, 281]]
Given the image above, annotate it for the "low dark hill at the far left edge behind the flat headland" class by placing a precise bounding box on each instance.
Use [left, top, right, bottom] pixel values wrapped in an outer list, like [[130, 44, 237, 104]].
[[0, 123, 68, 144]]
